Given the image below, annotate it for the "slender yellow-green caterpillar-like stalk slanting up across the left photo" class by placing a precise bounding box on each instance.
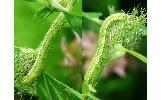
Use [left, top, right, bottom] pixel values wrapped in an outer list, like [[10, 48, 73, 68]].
[[22, 1, 73, 84]]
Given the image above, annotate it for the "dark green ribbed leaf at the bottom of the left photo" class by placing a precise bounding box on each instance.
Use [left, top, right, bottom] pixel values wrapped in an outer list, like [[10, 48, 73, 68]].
[[37, 74, 82, 100]]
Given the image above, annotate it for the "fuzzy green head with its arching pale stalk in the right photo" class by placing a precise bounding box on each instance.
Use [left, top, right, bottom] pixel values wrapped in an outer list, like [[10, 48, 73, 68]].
[[83, 12, 146, 97]]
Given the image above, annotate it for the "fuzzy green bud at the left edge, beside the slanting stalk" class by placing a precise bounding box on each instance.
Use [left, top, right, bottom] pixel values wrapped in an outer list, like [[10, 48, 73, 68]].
[[14, 47, 37, 90]]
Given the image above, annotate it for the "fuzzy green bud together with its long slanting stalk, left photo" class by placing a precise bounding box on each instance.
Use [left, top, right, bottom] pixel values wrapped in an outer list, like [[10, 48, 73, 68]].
[[14, 0, 74, 90]]
